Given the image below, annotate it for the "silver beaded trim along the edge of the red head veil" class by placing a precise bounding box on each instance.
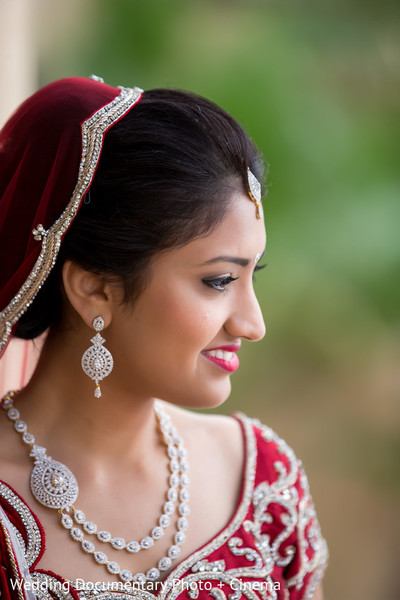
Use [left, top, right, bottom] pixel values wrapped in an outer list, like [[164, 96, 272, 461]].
[[0, 87, 143, 352]]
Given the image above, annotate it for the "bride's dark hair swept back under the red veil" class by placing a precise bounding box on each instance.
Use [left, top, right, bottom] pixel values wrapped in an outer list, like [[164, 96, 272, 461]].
[[16, 89, 263, 339]]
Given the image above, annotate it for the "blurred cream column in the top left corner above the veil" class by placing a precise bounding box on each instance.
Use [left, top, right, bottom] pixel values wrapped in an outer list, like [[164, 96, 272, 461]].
[[0, 0, 39, 127]]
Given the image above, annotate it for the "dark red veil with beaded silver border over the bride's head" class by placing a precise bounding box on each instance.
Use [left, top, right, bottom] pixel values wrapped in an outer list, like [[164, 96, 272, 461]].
[[0, 77, 142, 364]]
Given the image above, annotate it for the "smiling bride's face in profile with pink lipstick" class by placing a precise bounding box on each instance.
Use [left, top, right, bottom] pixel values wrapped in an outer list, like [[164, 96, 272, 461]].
[[105, 192, 266, 408]]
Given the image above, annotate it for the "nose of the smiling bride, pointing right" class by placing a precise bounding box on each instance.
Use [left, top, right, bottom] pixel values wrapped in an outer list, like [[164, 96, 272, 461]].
[[225, 289, 266, 342]]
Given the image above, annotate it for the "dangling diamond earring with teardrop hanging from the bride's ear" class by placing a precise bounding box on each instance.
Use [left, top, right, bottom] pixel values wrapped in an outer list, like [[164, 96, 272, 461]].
[[81, 316, 114, 398]]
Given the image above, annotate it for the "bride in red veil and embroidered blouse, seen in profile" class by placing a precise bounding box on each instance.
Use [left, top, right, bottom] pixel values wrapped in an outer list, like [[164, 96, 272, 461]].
[[0, 78, 327, 600]]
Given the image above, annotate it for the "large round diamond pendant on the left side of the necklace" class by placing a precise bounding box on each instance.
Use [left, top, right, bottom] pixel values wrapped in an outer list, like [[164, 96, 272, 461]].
[[30, 445, 79, 510]]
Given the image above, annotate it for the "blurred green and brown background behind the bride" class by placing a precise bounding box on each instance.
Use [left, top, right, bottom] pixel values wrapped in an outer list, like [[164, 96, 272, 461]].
[[28, 0, 400, 600]]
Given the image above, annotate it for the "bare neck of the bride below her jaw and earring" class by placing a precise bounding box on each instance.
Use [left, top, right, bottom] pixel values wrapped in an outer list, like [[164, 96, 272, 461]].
[[16, 333, 159, 472]]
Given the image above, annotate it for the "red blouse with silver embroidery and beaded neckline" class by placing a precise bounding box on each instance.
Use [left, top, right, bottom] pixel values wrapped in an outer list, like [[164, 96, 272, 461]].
[[0, 416, 328, 600]]
